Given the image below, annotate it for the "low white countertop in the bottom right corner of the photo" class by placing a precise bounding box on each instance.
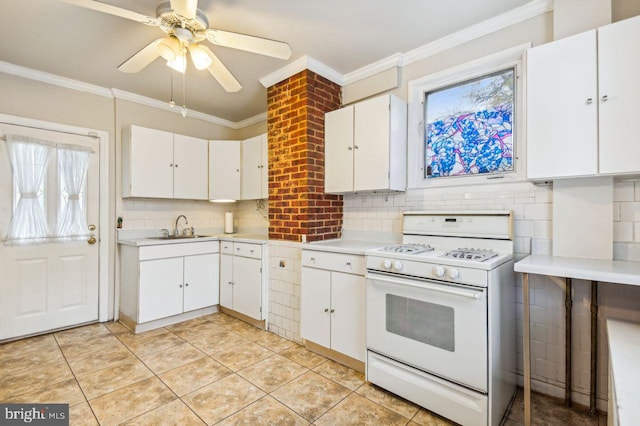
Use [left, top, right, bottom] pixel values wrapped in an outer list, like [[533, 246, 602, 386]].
[[607, 319, 640, 425]]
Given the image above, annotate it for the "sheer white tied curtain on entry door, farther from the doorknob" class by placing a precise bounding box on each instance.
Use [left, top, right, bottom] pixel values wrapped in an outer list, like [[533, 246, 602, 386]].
[[6, 135, 54, 244]]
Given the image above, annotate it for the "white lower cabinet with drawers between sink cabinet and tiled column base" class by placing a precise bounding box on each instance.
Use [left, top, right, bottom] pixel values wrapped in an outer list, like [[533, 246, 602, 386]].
[[220, 241, 267, 321]]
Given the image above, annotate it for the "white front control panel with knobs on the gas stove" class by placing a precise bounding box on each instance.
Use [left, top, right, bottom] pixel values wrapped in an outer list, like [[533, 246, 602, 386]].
[[366, 255, 487, 286]]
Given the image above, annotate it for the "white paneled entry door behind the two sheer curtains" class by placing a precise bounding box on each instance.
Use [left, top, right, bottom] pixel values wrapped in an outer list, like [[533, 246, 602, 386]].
[[0, 125, 101, 340]]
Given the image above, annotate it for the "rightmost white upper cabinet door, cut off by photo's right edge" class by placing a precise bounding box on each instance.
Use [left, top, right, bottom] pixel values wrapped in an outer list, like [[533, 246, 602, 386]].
[[598, 17, 640, 173]]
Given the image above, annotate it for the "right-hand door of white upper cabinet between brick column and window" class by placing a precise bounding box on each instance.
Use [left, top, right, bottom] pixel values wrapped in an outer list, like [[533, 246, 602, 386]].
[[353, 96, 390, 191]]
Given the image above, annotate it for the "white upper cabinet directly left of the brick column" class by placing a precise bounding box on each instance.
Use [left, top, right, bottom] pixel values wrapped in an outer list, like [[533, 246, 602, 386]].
[[242, 133, 269, 200]]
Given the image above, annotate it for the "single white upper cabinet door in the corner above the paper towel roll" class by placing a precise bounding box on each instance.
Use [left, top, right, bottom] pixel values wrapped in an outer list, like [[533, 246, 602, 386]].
[[209, 141, 241, 200]]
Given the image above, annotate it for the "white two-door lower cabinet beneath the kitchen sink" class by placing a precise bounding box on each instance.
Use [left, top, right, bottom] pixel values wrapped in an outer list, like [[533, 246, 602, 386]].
[[120, 241, 220, 331]]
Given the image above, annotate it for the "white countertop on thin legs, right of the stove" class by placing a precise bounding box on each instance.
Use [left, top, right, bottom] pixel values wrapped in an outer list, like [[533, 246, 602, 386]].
[[513, 254, 640, 285]]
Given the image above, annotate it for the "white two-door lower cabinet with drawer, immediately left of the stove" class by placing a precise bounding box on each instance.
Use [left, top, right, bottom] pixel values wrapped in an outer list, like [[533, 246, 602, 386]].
[[301, 250, 366, 362]]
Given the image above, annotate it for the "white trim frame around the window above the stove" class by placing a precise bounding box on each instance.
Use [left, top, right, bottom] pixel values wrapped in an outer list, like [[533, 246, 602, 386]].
[[407, 43, 531, 189]]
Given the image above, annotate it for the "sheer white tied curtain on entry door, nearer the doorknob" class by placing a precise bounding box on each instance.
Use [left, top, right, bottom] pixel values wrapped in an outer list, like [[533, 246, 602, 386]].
[[56, 145, 91, 241]]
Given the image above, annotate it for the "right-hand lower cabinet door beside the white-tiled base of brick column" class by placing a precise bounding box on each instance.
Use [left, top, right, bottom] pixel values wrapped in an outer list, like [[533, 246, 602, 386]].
[[233, 256, 262, 320]]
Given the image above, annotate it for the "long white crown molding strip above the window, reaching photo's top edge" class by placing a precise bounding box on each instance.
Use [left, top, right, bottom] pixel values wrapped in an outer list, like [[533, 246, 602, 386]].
[[401, 0, 553, 66]]
